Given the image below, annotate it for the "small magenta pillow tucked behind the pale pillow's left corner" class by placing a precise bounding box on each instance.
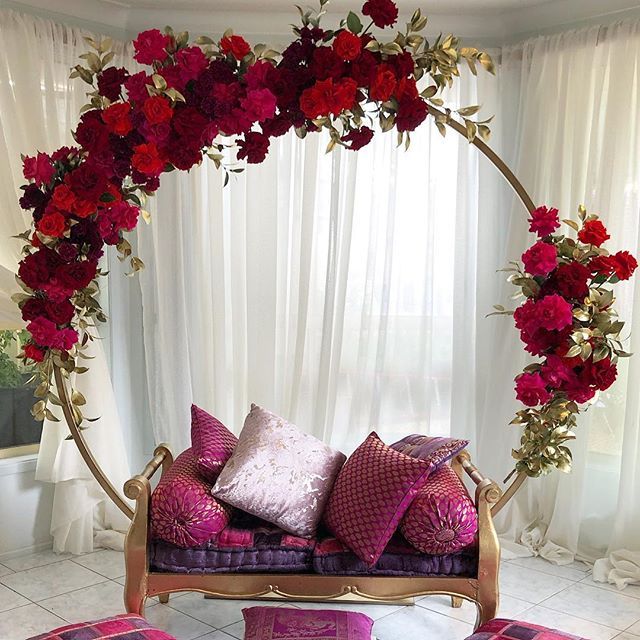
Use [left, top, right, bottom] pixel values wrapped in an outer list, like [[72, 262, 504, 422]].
[[191, 404, 238, 484]]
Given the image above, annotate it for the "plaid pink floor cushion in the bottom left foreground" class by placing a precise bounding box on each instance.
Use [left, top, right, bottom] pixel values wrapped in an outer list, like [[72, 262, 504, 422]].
[[27, 613, 176, 640]]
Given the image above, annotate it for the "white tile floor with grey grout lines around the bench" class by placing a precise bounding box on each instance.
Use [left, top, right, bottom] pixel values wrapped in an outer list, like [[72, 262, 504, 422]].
[[0, 551, 640, 640]]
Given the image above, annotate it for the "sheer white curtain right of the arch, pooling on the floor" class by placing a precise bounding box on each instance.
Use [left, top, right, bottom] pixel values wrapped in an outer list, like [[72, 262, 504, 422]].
[[483, 22, 640, 586]]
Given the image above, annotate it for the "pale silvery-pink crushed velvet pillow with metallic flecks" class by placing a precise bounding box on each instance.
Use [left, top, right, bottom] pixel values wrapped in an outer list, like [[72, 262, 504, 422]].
[[213, 405, 346, 538]]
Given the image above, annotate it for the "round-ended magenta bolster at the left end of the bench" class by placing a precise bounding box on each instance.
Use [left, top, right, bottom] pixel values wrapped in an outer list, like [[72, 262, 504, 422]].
[[151, 449, 232, 548]]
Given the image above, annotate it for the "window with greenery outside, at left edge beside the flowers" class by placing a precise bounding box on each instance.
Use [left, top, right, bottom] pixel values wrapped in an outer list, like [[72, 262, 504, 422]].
[[0, 330, 42, 458]]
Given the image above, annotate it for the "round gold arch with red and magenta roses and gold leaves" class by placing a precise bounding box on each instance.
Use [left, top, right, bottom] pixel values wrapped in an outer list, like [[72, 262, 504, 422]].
[[14, 0, 637, 517]]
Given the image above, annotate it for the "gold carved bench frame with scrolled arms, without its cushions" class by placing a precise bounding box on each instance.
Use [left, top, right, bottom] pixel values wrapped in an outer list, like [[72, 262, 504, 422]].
[[124, 444, 502, 624]]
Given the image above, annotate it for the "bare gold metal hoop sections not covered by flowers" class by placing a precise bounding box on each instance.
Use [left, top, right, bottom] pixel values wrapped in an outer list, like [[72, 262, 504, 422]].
[[53, 106, 536, 520]]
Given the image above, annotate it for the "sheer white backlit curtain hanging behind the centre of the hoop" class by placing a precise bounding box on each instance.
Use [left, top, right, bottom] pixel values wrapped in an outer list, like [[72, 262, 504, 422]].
[[138, 70, 510, 456]]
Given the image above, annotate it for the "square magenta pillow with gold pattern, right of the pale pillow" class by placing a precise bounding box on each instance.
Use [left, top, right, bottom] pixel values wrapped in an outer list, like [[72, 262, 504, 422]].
[[324, 432, 432, 566]]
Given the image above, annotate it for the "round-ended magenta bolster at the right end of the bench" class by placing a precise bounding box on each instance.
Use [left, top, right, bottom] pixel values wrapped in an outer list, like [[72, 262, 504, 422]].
[[400, 465, 478, 555]]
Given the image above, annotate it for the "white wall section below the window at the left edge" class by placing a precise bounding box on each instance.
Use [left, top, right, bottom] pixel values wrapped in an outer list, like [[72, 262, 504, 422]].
[[0, 456, 53, 563]]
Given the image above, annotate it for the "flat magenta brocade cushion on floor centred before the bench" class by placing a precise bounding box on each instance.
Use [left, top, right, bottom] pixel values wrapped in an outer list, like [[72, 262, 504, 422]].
[[242, 607, 373, 640]]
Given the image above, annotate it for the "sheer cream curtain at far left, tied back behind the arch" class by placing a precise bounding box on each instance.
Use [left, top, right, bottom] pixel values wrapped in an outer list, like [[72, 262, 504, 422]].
[[0, 9, 129, 553]]
